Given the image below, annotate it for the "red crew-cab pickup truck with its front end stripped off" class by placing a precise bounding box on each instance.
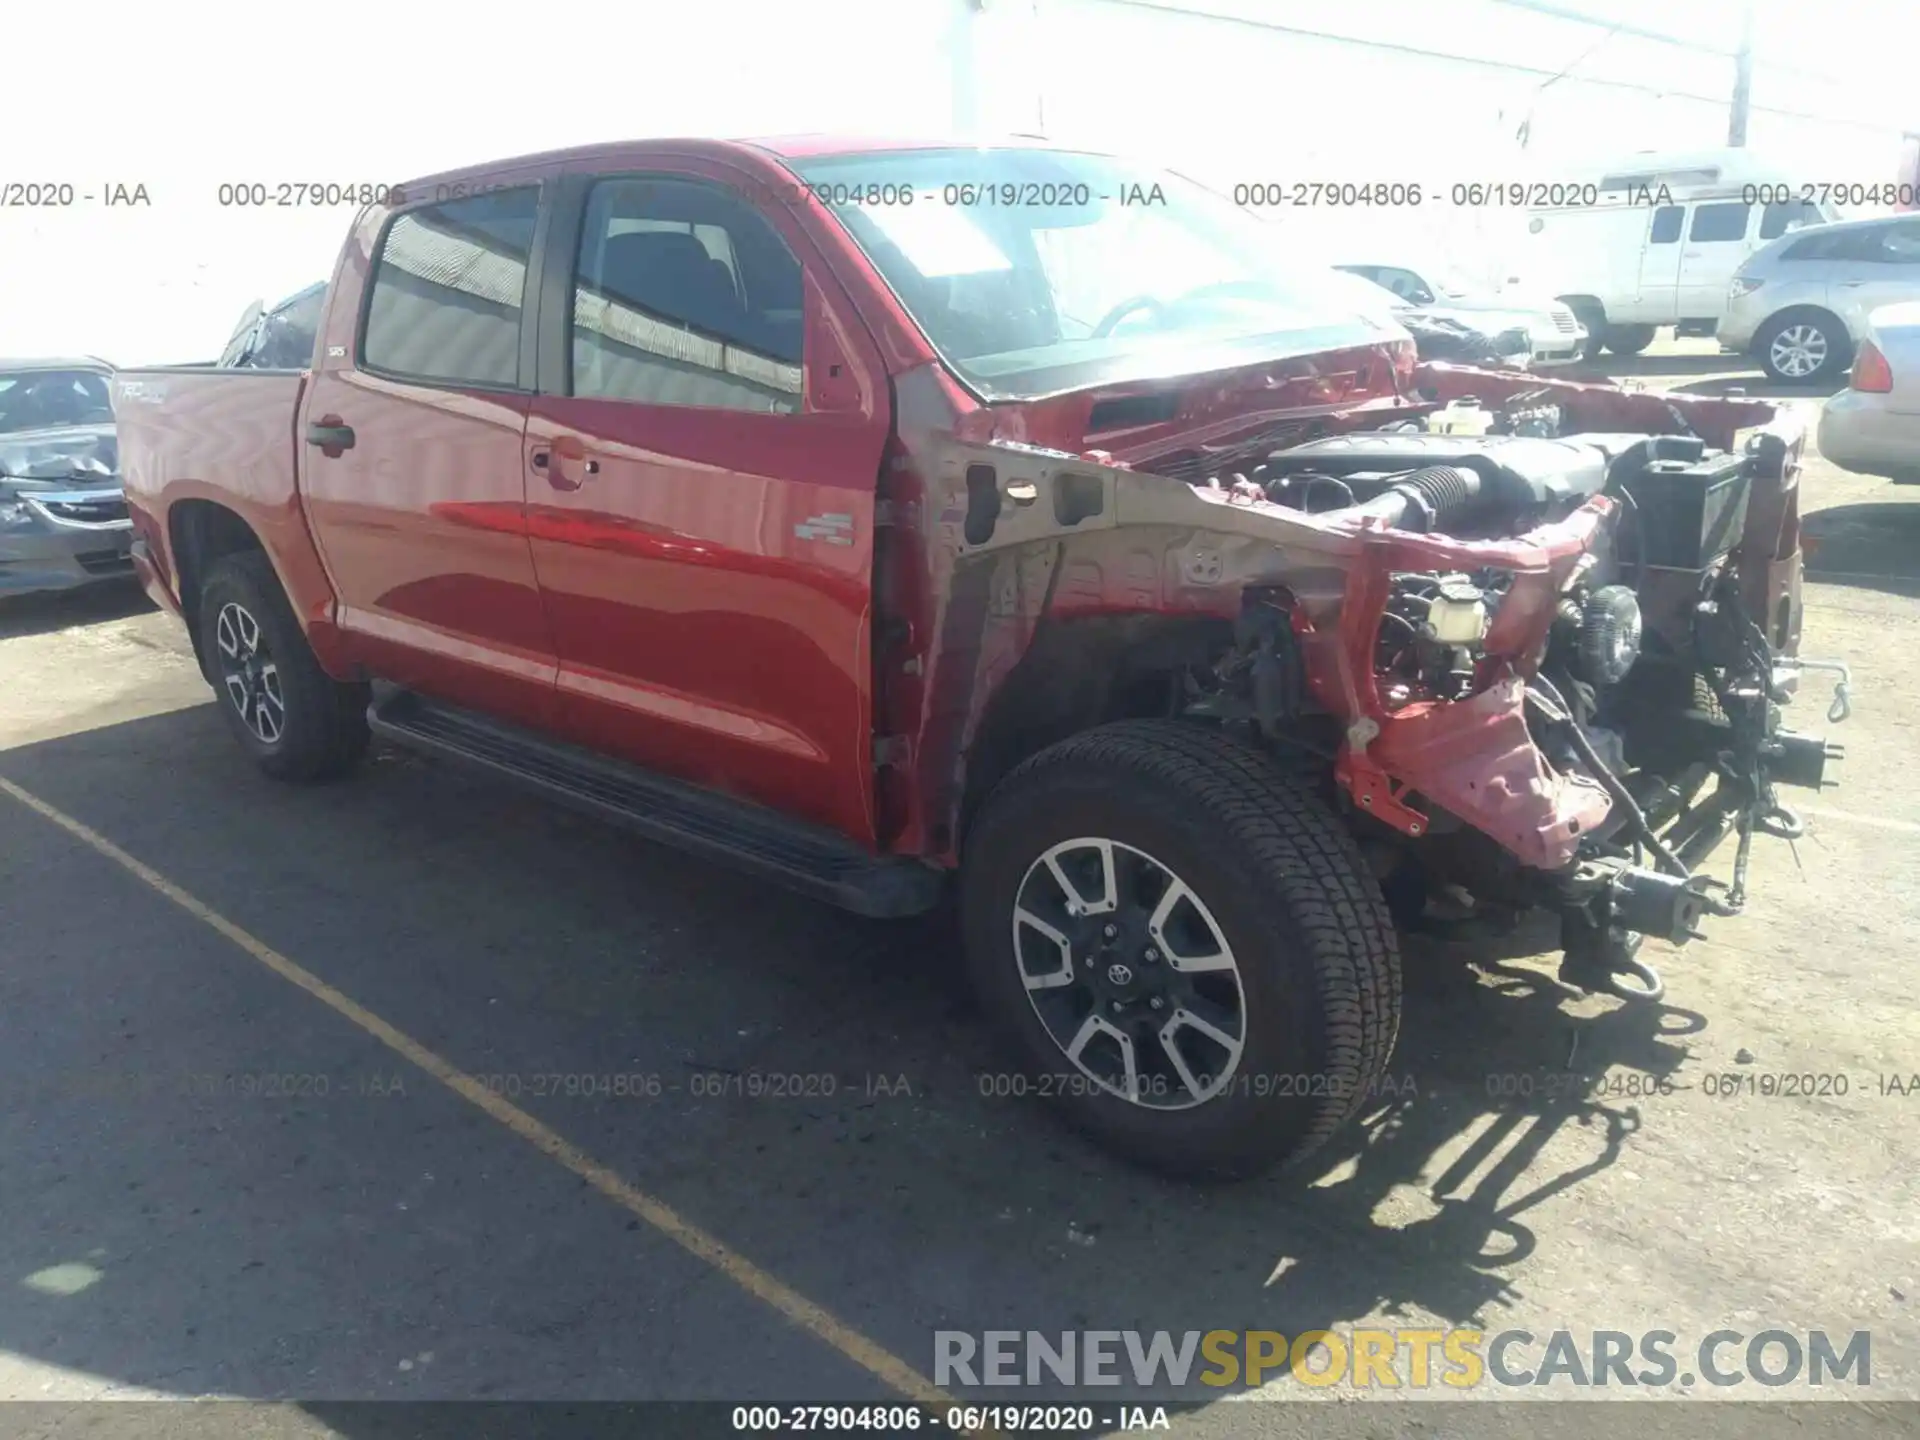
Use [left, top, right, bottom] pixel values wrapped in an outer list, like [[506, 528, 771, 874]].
[[115, 138, 1845, 1175]]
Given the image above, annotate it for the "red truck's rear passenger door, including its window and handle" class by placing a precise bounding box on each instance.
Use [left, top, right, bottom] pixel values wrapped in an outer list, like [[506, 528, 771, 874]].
[[296, 175, 555, 724]]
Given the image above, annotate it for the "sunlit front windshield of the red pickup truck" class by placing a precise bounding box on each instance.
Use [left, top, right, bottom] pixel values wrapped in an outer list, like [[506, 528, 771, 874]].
[[797, 148, 1392, 399]]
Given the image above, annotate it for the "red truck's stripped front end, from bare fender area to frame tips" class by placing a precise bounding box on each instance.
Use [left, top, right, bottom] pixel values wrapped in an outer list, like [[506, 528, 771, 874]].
[[876, 353, 1847, 998]]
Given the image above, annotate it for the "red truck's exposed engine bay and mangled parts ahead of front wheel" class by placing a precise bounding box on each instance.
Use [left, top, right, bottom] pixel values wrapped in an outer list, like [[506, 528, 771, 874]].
[[1156, 384, 1843, 1000]]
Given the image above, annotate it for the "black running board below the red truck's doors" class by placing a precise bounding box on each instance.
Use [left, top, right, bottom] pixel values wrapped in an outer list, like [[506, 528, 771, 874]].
[[367, 685, 945, 918]]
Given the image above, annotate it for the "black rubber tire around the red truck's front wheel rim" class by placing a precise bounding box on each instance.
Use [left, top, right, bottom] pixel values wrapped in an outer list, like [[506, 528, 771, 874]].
[[960, 720, 1402, 1179]]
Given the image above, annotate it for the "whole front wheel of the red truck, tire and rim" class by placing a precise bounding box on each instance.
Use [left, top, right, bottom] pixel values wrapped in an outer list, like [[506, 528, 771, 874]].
[[962, 720, 1400, 1179]]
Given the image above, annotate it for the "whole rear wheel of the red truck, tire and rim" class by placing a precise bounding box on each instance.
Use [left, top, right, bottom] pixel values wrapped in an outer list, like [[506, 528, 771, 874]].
[[200, 551, 369, 780]]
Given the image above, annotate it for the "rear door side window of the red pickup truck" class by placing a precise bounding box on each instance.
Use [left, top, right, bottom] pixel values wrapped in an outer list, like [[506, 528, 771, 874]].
[[361, 186, 540, 386]]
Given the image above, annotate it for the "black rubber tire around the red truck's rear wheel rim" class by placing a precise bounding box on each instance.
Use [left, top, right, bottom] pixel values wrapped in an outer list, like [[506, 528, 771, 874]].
[[200, 551, 371, 781]]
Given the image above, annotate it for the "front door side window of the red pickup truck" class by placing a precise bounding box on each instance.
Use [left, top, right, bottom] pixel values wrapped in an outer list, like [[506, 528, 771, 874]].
[[572, 179, 804, 415]]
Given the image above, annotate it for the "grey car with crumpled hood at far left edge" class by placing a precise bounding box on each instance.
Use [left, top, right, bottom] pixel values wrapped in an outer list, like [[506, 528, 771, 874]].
[[0, 355, 132, 593]]
